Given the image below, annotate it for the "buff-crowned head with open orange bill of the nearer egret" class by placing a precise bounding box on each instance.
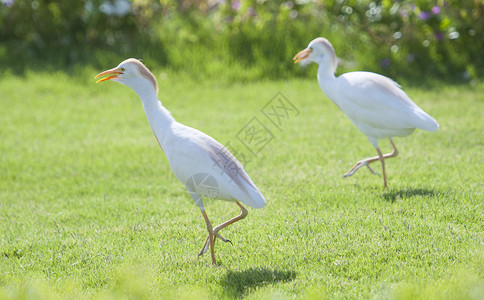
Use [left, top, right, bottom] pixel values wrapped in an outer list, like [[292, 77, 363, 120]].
[[95, 58, 158, 93]]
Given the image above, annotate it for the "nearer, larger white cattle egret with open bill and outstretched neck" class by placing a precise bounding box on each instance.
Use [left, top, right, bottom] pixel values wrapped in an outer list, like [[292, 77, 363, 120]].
[[96, 58, 266, 265]]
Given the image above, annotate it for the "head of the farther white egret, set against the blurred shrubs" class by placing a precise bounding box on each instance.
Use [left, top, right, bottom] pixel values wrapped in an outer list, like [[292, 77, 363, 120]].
[[293, 37, 337, 71]]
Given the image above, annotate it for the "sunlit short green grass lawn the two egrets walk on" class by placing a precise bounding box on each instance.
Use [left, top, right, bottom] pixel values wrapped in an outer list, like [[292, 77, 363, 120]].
[[0, 66, 484, 299]]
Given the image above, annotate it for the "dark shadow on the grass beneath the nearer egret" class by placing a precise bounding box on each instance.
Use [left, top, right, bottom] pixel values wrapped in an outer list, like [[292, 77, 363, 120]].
[[221, 268, 296, 298]]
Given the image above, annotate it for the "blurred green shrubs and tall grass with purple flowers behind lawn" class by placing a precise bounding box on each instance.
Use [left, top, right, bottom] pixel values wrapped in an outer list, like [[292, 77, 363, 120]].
[[0, 0, 484, 82]]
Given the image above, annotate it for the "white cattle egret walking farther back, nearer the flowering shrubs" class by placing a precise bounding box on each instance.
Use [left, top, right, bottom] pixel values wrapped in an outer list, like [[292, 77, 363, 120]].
[[294, 37, 439, 188]]
